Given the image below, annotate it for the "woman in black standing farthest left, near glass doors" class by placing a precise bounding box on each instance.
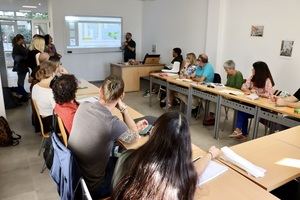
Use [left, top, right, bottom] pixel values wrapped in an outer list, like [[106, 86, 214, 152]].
[[12, 34, 29, 101]]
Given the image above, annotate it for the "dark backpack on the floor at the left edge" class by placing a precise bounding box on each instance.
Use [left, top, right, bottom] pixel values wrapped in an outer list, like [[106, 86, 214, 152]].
[[0, 116, 21, 147]]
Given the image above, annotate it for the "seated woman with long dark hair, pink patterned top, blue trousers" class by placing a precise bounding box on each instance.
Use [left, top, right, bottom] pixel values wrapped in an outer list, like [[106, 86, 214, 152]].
[[229, 61, 275, 139]]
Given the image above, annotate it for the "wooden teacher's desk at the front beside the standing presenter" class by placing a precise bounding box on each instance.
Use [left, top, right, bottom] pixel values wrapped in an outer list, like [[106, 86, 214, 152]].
[[110, 64, 164, 92]]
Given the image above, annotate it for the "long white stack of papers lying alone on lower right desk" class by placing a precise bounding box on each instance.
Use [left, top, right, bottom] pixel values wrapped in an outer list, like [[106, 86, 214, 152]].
[[221, 147, 267, 178]]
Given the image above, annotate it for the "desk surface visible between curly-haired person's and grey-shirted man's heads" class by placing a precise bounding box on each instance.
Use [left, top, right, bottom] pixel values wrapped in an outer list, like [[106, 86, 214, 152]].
[[76, 79, 99, 98]]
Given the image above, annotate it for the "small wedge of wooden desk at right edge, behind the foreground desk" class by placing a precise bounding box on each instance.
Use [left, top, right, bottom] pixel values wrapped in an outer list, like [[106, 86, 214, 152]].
[[268, 126, 300, 148]]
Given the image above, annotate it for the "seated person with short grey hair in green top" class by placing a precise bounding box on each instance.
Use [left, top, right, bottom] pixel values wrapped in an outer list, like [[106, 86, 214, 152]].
[[223, 60, 244, 89]]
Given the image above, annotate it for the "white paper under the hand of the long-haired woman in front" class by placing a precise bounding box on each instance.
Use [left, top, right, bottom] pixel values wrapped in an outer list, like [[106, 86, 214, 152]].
[[197, 161, 228, 186]]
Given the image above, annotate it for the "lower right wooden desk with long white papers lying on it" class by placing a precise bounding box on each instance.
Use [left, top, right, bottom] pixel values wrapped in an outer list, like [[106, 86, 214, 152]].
[[222, 136, 300, 191]]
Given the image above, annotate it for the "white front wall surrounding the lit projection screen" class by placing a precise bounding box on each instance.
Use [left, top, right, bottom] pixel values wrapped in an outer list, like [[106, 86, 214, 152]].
[[49, 0, 142, 81]]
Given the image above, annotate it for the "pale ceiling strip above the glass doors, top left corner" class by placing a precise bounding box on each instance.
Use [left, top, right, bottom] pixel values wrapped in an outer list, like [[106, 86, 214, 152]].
[[0, 0, 48, 13]]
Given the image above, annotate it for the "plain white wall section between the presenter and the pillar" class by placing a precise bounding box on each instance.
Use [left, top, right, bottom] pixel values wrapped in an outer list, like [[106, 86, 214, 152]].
[[142, 0, 207, 63]]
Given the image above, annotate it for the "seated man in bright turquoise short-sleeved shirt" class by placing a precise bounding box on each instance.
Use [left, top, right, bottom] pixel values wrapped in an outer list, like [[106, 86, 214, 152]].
[[192, 54, 215, 83]]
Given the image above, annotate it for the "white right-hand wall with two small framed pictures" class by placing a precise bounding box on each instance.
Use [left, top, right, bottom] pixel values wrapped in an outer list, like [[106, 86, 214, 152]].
[[222, 0, 300, 92]]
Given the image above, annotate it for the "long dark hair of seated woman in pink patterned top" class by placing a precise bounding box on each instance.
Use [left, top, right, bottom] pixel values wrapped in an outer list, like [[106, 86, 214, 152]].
[[251, 61, 275, 88]]
